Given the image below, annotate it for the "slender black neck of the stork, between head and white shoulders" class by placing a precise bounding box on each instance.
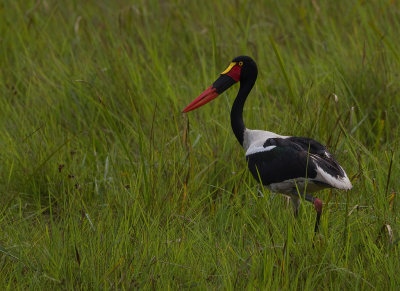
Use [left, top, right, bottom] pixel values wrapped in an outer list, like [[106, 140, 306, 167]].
[[231, 75, 257, 146]]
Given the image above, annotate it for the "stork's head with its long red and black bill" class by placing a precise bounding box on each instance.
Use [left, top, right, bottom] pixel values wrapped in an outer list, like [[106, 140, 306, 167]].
[[183, 56, 258, 112]]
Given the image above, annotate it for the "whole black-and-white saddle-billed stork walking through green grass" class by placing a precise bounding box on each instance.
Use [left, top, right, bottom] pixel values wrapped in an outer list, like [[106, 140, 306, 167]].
[[183, 56, 352, 232]]
